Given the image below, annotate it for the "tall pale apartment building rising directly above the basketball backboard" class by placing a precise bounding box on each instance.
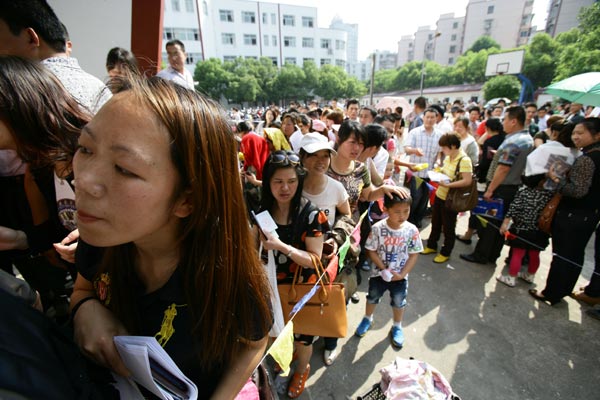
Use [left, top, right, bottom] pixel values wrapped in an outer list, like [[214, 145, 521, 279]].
[[461, 0, 533, 54]]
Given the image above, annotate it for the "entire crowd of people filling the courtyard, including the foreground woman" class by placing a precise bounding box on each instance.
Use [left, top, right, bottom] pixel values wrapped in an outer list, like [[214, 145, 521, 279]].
[[0, 0, 600, 398]]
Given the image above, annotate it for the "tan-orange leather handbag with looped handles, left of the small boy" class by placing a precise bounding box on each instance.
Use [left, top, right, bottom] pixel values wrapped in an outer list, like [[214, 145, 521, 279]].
[[277, 254, 348, 338]]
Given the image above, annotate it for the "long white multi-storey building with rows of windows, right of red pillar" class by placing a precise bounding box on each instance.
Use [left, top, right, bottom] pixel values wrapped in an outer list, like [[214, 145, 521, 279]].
[[163, 0, 348, 72]]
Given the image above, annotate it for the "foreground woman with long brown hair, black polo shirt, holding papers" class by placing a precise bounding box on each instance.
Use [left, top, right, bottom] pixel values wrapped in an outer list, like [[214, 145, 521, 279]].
[[72, 78, 272, 398]]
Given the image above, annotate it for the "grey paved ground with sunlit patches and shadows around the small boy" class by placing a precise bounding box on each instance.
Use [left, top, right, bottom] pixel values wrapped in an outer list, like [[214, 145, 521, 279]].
[[282, 217, 600, 400]]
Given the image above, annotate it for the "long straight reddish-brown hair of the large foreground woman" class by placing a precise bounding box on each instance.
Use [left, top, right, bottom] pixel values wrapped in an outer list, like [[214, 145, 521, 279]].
[[101, 77, 271, 368]]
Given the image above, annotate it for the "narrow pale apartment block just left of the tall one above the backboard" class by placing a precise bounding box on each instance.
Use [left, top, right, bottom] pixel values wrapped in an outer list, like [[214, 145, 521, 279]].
[[433, 13, 465, 65]]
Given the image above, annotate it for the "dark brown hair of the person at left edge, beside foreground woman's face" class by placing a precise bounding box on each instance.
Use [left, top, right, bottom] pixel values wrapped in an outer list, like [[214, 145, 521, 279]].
[[0, 56, 91, 169]]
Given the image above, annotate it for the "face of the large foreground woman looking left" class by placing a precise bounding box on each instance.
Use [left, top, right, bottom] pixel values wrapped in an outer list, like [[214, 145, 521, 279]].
[[73, 93, 191, 247]]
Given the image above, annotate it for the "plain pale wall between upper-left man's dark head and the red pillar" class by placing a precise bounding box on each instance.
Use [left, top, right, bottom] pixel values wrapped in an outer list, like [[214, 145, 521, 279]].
[[48, 0, 131, 80]]
